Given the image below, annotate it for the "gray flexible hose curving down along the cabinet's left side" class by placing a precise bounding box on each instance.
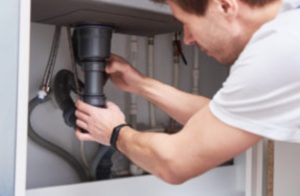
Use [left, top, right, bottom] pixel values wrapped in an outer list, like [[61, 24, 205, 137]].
[[28, 96, 91, 182]]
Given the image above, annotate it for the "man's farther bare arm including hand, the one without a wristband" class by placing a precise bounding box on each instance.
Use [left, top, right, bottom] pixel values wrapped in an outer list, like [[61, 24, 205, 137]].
[[106, 55, 209, 124]]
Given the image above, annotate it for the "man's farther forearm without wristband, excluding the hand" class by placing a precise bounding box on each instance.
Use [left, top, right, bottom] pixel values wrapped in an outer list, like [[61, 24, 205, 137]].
[[138, 78, 209, 124]]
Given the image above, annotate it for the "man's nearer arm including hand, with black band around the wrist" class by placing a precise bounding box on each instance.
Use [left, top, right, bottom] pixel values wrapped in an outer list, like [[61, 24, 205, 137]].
[[76, 101, 261, 184]]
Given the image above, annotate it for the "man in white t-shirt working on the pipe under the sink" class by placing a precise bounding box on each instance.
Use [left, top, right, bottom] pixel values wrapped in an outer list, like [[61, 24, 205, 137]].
[[76, 0, 300, 184]]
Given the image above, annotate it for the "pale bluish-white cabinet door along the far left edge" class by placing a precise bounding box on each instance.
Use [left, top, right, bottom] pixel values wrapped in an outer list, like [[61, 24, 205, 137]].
[[0, 0, 21, 196]]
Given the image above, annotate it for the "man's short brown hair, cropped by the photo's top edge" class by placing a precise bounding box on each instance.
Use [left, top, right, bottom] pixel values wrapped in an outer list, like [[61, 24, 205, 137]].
[[152, 0, 276, 15]]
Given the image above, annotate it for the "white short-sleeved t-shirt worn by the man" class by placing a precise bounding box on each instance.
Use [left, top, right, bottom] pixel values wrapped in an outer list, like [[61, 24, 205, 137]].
[[210, 1, 300, 143]]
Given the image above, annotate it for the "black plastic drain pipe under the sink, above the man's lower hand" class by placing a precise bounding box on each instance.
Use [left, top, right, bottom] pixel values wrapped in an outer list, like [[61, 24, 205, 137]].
[[73, 25, 113, 107]]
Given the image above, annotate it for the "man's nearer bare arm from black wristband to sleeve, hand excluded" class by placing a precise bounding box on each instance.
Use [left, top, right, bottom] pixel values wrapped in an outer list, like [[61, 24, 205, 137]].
[[117, 105, 261, 184]]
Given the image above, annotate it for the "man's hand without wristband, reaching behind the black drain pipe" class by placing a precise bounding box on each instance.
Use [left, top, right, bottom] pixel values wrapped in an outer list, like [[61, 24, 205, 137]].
[[105, 54, 146, 94]]
